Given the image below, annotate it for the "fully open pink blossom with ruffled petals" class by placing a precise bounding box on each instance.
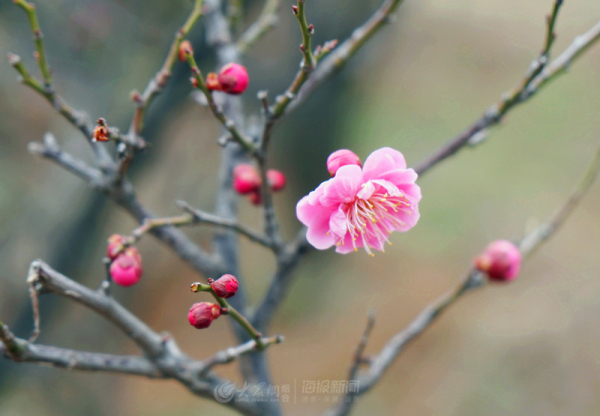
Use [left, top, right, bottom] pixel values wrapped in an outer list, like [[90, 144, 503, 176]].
[[296, 147, 421, 255]]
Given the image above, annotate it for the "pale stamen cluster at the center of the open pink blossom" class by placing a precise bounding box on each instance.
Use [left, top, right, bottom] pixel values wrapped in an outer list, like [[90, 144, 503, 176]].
[[338, 188, 411, 256]]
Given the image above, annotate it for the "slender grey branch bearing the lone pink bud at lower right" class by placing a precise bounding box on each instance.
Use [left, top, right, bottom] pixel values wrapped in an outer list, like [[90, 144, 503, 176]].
[[326, 136, 600, 416]]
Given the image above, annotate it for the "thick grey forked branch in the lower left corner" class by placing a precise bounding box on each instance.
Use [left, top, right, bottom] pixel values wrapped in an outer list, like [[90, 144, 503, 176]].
[[0, 260, 274, 416]]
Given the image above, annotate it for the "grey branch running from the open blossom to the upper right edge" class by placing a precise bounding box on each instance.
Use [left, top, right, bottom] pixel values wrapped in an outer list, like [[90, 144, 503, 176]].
[[415, 6, 600, 175]]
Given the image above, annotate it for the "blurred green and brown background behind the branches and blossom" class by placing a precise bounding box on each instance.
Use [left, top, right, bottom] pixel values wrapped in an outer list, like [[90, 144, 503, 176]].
[[0, 0, 600, 416]]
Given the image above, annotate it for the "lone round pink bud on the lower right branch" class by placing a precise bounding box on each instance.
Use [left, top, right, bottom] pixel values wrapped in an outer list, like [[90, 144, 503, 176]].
[[474, 240, 521, 281]]
